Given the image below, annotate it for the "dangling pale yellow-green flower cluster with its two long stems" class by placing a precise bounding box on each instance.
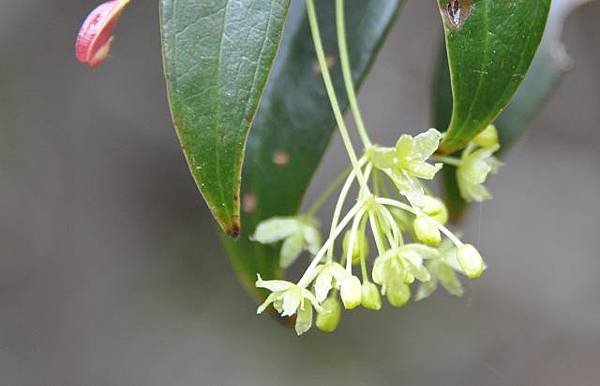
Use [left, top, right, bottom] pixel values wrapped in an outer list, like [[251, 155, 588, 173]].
[[247, 0, 500, 335]]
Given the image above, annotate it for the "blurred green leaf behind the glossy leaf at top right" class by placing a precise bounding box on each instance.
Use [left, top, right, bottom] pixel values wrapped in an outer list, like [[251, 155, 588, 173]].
[[433, 0, 591, 222]]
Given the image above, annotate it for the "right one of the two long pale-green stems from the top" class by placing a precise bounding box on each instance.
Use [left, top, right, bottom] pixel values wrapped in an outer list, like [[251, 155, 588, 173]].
[[335, 0, 371, 147]]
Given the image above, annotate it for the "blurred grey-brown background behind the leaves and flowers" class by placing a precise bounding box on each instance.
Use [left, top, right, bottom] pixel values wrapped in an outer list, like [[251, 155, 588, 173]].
[[0, 0, 600, 386]]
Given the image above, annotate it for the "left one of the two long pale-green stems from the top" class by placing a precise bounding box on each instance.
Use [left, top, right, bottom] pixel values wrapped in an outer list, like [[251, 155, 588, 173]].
[[306, 0, 369, 192]]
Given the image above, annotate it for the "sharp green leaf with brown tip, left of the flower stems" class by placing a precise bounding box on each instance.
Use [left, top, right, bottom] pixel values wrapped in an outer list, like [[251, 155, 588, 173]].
[[160, 0, 290, 236]]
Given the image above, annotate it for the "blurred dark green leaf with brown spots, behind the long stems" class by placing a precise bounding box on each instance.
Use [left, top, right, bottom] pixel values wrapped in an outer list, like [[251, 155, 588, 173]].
[[222, 0, 402, 298]]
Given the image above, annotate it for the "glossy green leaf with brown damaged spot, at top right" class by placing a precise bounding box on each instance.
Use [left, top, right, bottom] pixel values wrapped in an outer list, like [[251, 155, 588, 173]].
[[438, 0, 550, 153]]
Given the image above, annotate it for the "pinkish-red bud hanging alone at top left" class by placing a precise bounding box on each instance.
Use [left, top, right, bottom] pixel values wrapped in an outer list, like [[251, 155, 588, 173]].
[[75, 0, 130, 68]]
